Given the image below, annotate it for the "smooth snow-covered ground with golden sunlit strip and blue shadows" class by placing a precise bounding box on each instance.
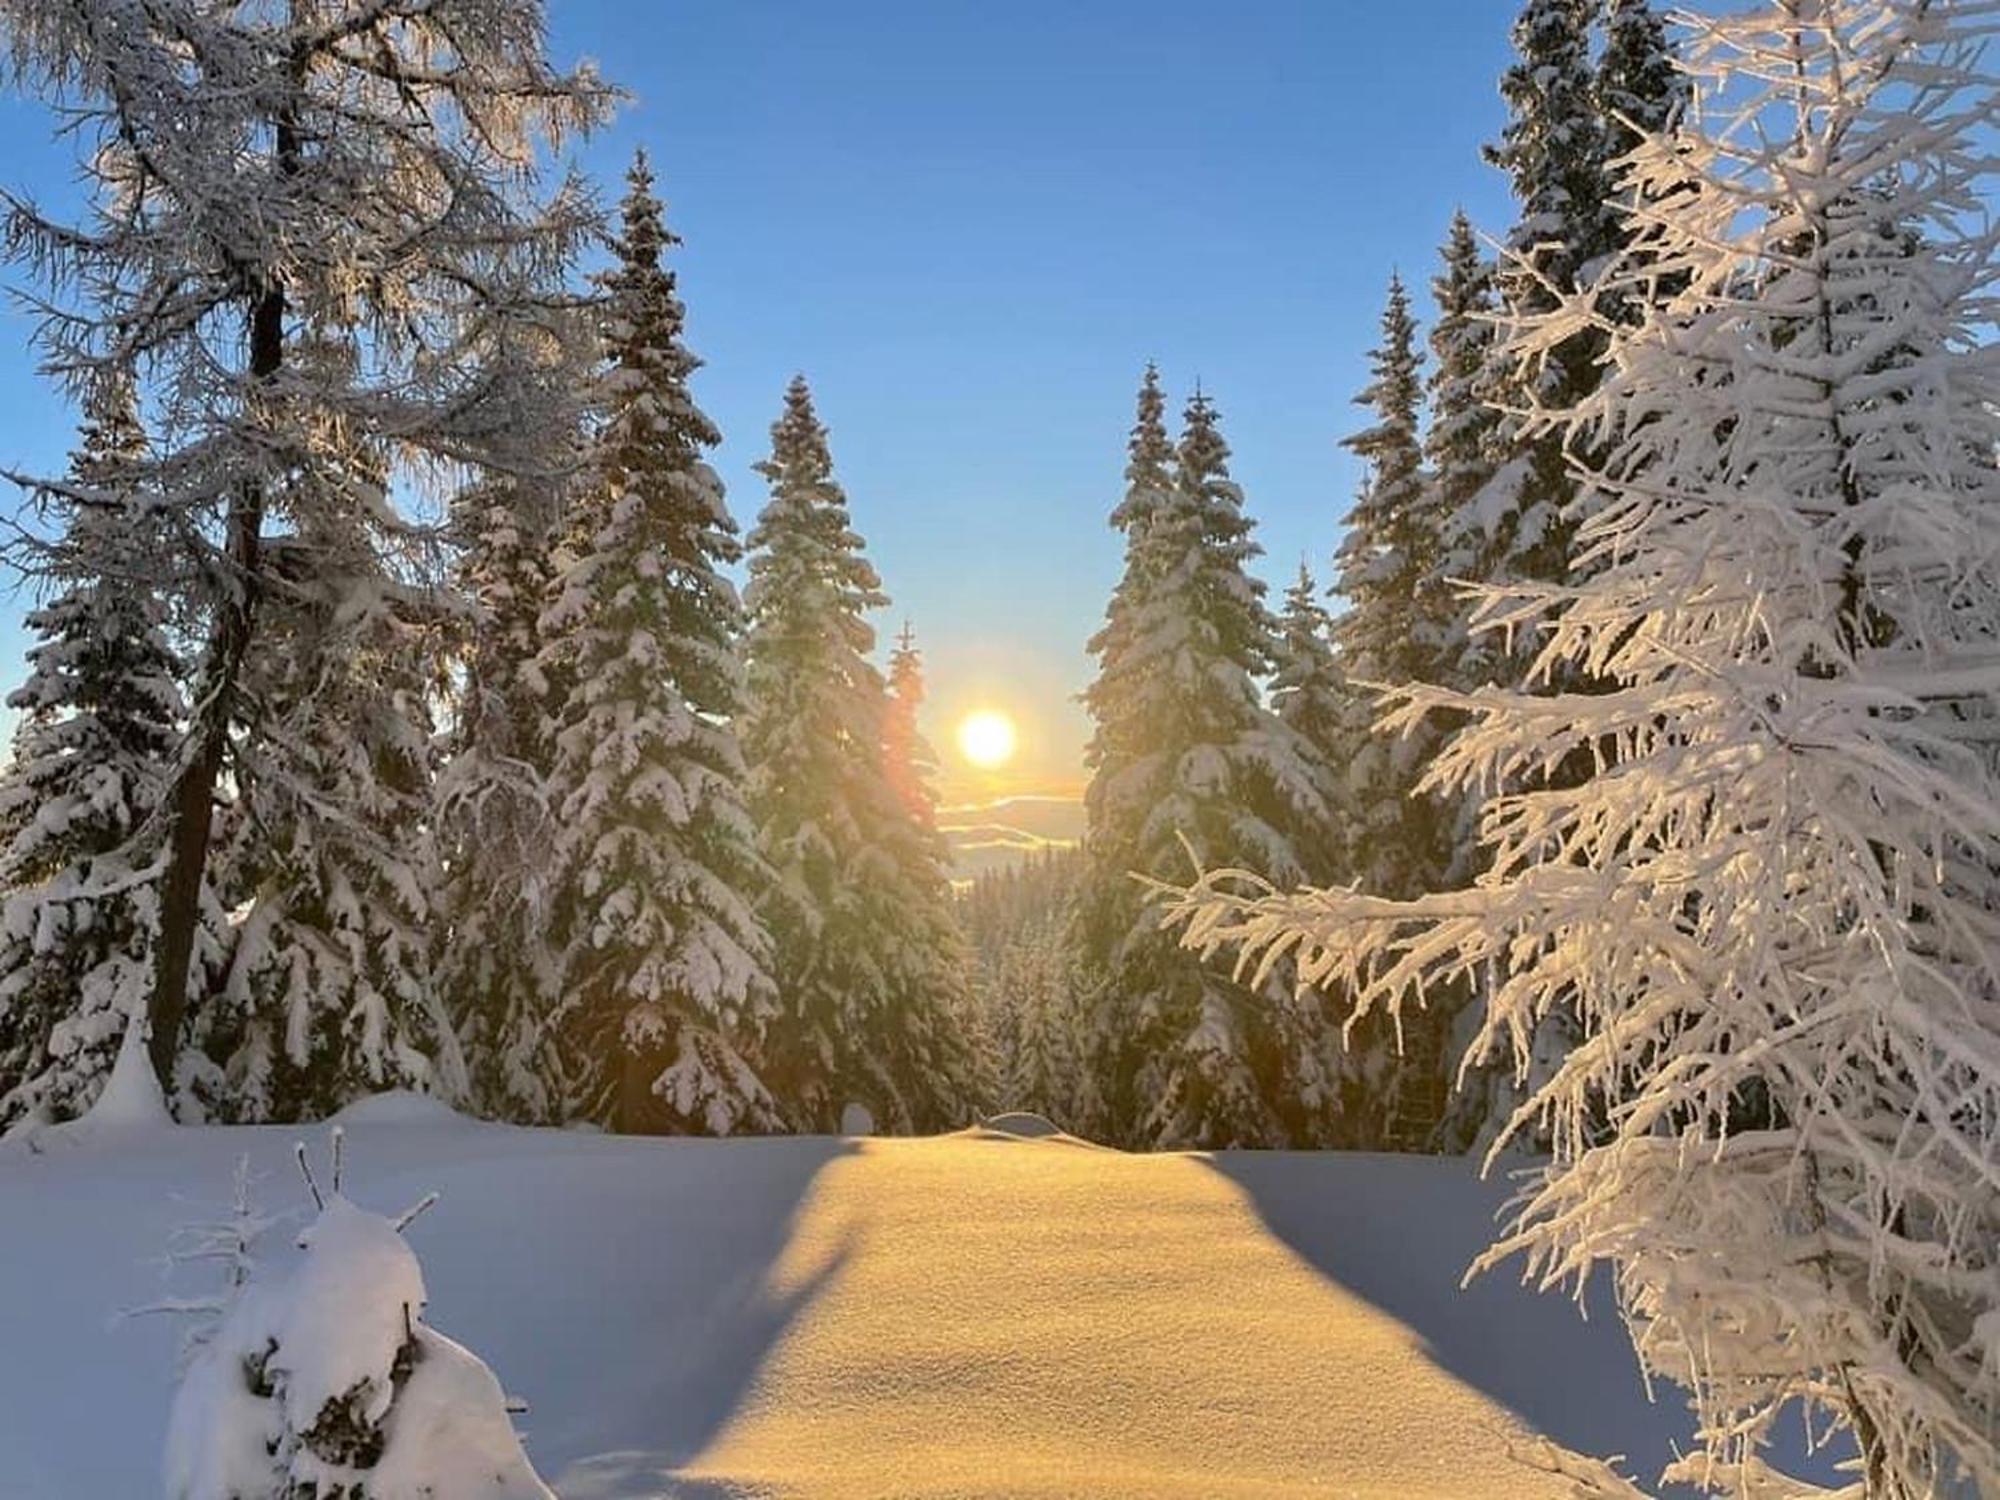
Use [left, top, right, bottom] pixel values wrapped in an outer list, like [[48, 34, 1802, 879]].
[[0, 1098, 1776, 1500]]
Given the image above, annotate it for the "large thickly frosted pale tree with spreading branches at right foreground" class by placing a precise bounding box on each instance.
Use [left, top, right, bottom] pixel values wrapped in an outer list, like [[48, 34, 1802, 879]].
[[1180, 0, 2000, 1500]]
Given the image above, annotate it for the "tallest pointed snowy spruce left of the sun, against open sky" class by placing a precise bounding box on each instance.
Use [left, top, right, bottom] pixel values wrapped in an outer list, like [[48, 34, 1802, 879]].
[[540, 156, 780, 1136]]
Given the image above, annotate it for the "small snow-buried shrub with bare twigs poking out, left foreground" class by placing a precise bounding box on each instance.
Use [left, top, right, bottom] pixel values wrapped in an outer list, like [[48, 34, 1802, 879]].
[[166, 1128, 550, 1500]]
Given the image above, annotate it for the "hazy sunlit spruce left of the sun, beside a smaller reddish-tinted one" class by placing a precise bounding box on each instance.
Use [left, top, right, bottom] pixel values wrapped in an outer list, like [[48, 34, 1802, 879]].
[[744, 378, 966, 1130]]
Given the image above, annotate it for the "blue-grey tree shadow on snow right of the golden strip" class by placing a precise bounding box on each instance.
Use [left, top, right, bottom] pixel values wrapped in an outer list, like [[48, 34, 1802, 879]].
[[1208, 1152, 1834, 1494]]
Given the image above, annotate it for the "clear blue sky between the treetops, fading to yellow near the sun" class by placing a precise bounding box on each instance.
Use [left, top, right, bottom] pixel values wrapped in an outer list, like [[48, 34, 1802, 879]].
[[0, 0, 1516, 800]]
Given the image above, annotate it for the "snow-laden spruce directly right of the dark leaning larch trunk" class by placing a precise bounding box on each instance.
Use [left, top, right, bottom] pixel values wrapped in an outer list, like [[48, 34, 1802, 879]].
[[202, 524, 466, 1120]]
